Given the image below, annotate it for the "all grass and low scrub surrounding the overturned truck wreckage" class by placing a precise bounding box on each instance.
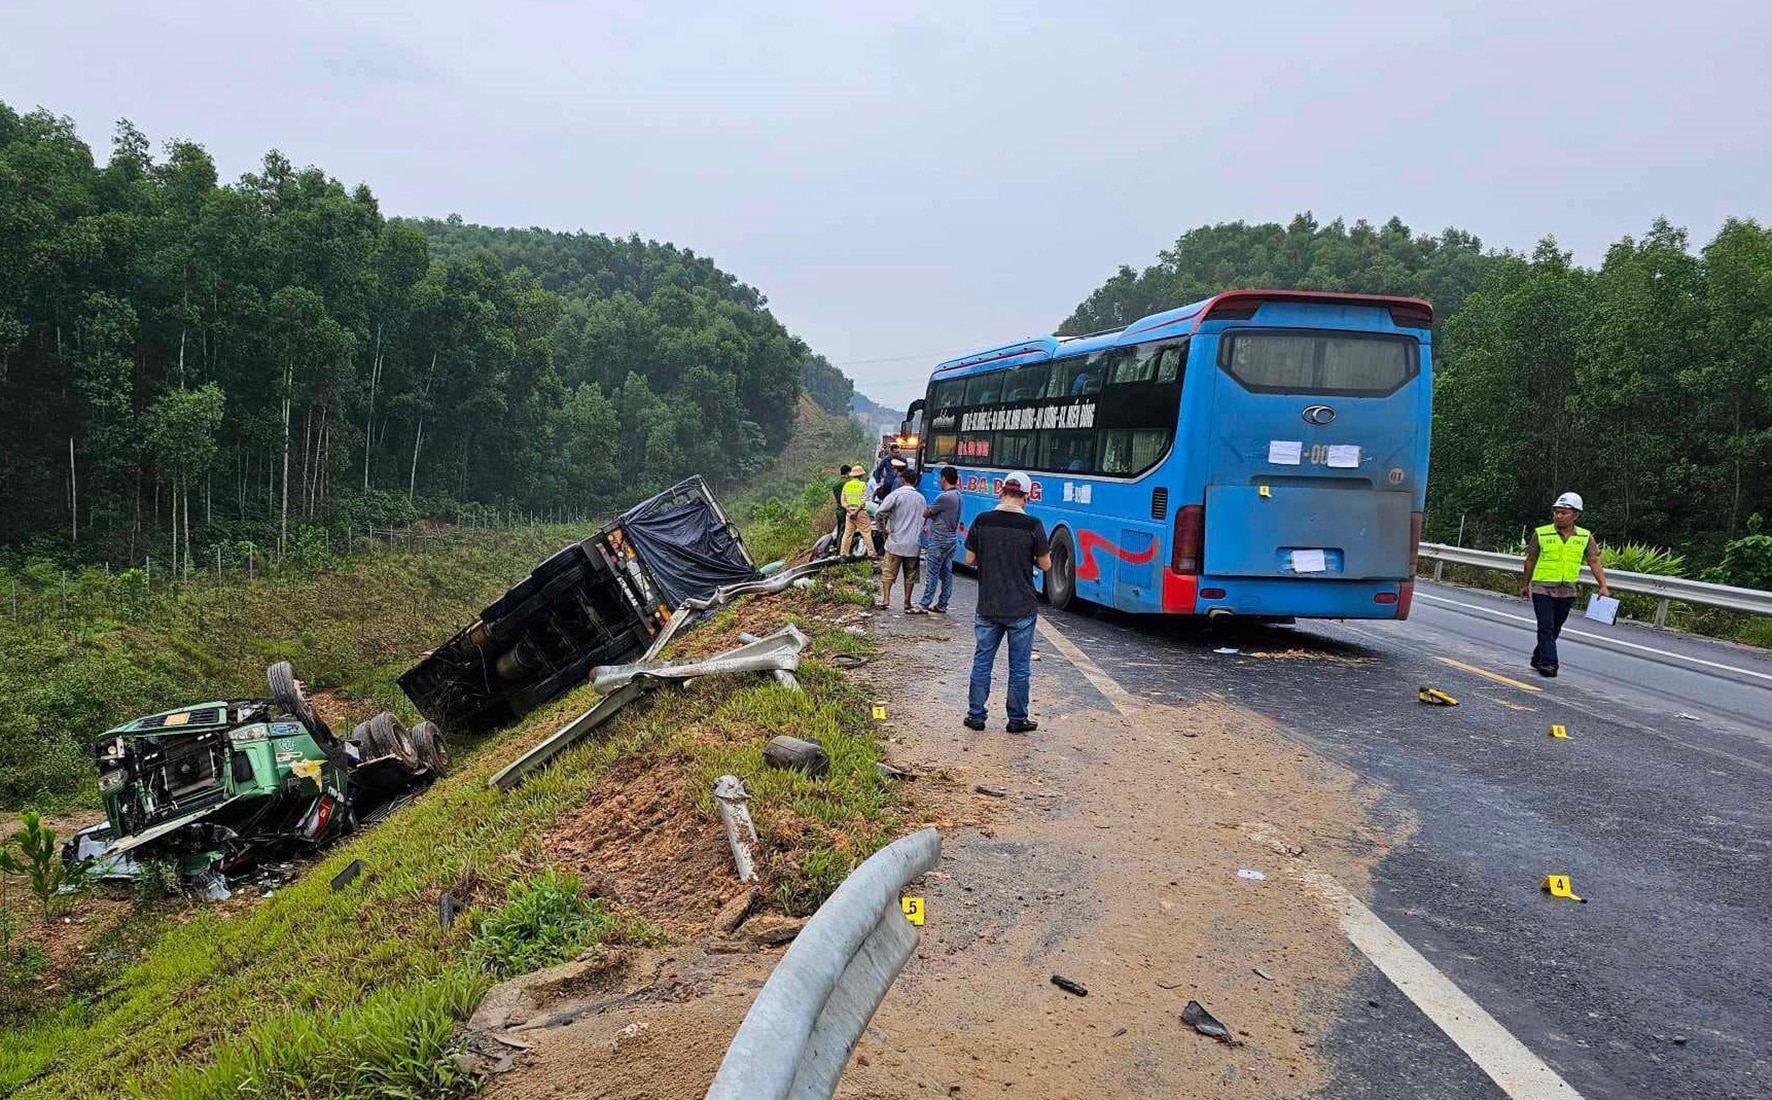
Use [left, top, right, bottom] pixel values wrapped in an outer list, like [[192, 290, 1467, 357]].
[[0, 402, 886, 1100]]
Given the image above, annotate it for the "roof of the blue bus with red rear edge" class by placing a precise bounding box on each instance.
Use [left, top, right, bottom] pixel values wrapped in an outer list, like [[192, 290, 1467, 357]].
[[932, 290, 1434, 374]]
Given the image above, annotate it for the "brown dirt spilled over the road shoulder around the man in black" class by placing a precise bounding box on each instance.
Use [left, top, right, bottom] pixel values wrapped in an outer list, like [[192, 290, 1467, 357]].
[[477, 613, 1407, 1100]]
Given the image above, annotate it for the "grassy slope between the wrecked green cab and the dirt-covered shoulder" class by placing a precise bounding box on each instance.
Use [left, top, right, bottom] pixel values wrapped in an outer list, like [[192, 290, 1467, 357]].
[[0, 508, 897, 1100]]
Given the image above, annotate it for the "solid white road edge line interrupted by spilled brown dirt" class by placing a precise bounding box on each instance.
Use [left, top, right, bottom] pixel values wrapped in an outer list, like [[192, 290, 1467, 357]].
[[1038, 616, 1581, 1100]]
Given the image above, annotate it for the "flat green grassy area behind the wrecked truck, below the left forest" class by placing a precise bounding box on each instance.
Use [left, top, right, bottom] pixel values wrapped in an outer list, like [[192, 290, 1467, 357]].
[[0, 526, 588, 810]]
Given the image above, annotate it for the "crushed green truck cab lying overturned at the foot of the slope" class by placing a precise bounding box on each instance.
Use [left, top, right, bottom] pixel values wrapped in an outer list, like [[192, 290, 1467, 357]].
[[64, 662, 448, 877]]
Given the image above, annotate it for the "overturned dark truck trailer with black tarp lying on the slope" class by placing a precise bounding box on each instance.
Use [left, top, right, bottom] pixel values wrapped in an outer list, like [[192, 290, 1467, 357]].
[[400, 476, 757, 733]]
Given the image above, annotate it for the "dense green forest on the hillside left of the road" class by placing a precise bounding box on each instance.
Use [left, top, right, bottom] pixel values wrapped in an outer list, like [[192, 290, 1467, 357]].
[[0, 105, 851, 563]]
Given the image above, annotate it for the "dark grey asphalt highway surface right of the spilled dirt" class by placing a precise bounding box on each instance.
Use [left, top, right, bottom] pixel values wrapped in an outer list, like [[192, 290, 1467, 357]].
[[1034, 585, 1772, 1100]]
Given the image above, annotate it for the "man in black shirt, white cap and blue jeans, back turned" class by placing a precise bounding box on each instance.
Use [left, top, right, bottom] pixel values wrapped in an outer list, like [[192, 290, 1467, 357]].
[[964, 469, 1053, 733]]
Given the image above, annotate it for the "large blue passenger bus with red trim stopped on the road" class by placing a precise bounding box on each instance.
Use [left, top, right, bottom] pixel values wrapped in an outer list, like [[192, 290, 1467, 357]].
[[904, 290, 1434, 618]]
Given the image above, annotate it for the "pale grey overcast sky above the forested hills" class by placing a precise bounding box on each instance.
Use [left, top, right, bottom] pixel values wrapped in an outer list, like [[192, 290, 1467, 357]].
[[0, 0, 1772, 404]]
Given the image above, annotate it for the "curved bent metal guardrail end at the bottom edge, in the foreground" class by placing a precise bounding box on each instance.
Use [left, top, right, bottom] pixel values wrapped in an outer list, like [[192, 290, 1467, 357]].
[[707, 829, 941, 1100]]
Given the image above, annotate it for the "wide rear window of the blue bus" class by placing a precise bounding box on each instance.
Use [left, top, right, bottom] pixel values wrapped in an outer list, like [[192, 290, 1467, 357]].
[[1219, 331, 1419, 397]]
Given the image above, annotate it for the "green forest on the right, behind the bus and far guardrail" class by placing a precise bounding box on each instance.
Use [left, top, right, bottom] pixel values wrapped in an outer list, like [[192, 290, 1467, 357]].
[[1063, 214, 1772, 573]]
